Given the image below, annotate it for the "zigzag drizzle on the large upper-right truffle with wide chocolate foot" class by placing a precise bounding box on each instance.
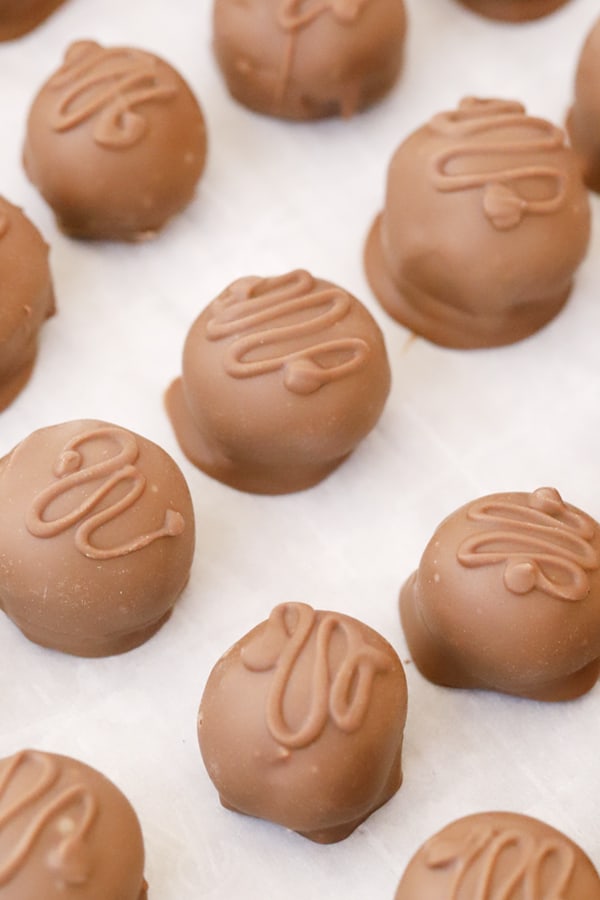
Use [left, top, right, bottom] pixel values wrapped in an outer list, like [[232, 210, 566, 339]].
[[430, 98, 566, 230]]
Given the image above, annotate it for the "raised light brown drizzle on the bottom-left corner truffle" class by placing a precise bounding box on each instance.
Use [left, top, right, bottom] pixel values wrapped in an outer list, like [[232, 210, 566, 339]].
[[0, 750, 98, 887]]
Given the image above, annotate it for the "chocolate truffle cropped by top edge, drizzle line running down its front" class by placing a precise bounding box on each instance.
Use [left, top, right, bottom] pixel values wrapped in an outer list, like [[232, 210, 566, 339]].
[[214, 0, 406, 119]]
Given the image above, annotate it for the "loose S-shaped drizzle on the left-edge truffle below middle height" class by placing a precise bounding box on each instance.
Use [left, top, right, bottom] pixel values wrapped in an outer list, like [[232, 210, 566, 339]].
[[25, 426, 185, 559]]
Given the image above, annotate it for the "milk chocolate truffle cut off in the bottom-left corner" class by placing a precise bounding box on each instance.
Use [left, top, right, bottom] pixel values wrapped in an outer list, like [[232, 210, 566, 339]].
[[0, 750, 147, 900]]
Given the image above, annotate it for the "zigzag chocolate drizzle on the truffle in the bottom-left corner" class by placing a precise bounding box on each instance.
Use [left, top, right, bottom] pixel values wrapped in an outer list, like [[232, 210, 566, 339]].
[[0, 750, 98, 888]]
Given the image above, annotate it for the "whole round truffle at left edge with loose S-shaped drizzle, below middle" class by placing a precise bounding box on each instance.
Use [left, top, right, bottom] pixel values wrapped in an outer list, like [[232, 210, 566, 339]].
[[0, 420, 194, 656]]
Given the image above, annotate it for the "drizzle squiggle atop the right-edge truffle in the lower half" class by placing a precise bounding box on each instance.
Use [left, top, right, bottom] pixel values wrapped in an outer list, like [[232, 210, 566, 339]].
[[457, 488, 600, 601]]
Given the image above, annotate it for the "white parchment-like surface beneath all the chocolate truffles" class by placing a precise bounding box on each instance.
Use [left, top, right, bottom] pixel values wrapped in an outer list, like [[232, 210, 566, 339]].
[[0, 0, 600, 900]]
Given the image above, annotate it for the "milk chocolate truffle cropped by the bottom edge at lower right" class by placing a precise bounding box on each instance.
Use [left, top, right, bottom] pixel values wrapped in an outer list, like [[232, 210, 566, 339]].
[[395, 812, 600, 900]]
